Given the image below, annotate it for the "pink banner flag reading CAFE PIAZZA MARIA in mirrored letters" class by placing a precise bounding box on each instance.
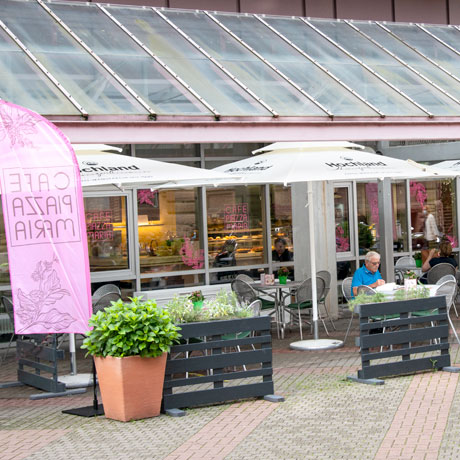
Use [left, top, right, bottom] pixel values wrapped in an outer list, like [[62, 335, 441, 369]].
[[0, 101, 91, 334]]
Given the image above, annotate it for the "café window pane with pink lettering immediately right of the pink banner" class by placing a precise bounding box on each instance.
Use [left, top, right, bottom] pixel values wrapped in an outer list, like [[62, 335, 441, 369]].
[[84, 196, 129, 272]]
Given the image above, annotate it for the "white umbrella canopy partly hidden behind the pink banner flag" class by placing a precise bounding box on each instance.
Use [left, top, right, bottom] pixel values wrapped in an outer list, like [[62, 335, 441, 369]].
[[73, 144, 237, 187]]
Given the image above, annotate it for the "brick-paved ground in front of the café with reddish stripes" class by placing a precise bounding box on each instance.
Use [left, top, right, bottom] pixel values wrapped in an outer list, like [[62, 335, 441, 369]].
[[0, 319, 460, 460]]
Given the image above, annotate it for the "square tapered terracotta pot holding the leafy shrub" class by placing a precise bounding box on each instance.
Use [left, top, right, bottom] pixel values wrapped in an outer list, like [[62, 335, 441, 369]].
[[94, 353, 167, 422]]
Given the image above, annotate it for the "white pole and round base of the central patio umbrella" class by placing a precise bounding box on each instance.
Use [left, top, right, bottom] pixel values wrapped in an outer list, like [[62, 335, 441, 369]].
[[290, 181, 343, 351]]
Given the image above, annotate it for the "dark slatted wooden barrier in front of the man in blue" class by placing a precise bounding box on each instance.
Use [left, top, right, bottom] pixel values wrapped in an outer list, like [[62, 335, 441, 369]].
[[358, 296, 450, 379]]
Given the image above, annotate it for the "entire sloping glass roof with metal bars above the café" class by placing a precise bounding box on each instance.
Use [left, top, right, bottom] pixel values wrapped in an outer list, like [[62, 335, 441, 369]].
[[0, 0, 460, 121]]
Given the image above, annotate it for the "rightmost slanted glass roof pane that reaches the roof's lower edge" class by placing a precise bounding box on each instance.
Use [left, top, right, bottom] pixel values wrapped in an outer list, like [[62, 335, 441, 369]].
[[311, 21, 460, 115]]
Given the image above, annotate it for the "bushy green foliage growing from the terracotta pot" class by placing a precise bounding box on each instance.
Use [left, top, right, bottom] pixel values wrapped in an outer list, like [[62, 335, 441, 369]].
[[82, 297, 180, 358]]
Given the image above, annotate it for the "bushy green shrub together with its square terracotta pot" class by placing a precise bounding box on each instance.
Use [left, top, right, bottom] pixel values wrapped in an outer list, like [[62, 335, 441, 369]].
[[82, 297, 180, 422]]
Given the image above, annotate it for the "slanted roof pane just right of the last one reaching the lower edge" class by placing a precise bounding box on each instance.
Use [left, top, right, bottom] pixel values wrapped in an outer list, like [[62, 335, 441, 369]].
[[354, 22, 460, 98]]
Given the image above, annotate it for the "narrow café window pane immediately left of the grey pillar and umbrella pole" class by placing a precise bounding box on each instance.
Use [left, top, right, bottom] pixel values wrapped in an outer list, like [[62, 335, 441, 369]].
[[270, 185, 294, 264]]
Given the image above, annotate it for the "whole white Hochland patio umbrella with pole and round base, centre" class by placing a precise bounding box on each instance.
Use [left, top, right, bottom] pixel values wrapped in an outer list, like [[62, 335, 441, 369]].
[[214, 141, 451, 350]]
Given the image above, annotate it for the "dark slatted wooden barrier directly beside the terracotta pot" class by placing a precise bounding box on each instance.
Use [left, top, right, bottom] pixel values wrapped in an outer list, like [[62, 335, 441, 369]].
[[163, 316, 273, 410]]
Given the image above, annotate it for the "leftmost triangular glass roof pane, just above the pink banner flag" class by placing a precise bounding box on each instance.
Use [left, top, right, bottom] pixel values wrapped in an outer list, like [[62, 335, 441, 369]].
[[0, 30, 80, 115]]
